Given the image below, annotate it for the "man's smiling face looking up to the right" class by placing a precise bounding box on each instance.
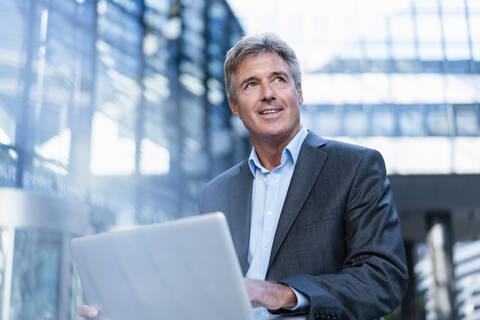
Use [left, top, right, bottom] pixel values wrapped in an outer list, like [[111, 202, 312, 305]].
[[229, 53, 303, 143]]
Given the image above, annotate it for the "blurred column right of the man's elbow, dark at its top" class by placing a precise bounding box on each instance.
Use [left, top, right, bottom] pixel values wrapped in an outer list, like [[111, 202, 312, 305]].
[[427, 211, 456, 320]]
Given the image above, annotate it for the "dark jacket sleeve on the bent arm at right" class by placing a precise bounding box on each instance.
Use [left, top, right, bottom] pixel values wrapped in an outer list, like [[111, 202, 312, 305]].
[[279, 150, 408, 319]]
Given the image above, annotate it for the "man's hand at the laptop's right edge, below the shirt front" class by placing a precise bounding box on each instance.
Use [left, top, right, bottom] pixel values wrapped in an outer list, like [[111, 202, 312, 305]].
[[245, 279, 297, 310]]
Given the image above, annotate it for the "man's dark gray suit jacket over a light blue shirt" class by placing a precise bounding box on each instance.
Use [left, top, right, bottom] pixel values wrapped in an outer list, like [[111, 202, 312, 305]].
[[200, 132, 408, 319]]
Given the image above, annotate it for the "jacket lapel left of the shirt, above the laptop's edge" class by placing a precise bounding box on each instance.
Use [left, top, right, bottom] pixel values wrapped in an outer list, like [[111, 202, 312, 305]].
[[227, 161, 253, 275]]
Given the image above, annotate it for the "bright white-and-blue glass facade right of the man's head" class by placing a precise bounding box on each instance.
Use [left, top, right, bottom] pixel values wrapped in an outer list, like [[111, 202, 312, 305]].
[[296, 0, 480, 174]]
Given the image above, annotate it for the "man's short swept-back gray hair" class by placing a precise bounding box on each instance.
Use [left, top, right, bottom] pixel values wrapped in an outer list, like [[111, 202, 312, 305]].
[[223, 33, 302, 103]]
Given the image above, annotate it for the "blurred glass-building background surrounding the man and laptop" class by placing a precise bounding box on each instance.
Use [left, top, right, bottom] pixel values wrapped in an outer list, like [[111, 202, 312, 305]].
[[0, 0, 480, 320]]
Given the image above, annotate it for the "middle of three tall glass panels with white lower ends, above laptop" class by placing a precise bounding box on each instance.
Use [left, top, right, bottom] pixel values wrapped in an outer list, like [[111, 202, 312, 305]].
[[90, 28, 141, 176]]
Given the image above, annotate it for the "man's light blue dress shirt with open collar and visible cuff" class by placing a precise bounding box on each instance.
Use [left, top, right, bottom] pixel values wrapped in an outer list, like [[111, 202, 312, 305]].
[[246, 127, 308, 319]]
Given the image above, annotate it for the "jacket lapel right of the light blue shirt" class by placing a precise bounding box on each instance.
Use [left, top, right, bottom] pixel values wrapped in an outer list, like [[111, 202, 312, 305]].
[[268, 132, 327, 268]]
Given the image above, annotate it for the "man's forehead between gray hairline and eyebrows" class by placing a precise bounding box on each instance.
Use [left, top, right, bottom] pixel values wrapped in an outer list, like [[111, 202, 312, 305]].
[[235, 52, 292, 80]]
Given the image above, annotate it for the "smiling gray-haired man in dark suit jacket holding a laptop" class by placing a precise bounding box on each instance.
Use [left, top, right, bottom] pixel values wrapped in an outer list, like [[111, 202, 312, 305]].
[[80, 34, 408, 319]]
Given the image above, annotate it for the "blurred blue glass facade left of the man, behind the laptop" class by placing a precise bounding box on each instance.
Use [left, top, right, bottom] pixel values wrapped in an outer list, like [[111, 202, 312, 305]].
[[0, 0, 240, 319]]
